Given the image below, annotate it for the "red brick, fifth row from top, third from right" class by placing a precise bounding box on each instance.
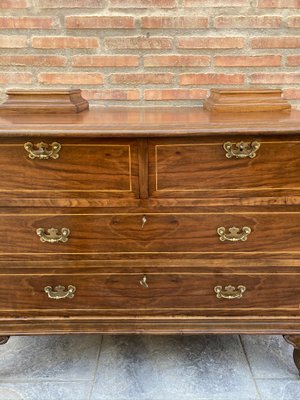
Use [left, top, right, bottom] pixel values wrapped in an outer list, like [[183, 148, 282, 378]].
[[110, 73, 173, 85]]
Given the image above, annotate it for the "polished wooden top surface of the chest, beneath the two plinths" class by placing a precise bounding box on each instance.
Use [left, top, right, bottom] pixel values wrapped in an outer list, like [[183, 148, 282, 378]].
[[0, 107, 300, 137]]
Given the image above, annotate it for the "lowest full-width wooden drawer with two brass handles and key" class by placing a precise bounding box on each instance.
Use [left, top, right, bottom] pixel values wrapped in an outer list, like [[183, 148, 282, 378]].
[[0, 272, 300, 315]]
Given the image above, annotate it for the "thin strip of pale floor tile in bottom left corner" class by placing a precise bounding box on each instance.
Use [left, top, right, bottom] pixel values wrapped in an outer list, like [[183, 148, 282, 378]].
[[0, 381, 91, 400]]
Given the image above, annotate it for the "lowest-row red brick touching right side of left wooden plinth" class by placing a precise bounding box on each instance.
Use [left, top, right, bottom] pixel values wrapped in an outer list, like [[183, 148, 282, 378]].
[[82, 89, 141, 101]]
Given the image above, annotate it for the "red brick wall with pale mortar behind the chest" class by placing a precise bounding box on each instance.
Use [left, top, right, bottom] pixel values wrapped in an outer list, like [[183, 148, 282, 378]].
[[0, 0, 300, 108]]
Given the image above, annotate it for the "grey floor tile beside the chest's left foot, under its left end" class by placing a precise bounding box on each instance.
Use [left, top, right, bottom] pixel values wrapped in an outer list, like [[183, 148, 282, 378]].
[[0, 335, 101, 385]]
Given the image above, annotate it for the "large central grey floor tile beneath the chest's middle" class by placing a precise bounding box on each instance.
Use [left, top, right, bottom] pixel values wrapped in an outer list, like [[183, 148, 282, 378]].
[[91, 335, 259, 400]]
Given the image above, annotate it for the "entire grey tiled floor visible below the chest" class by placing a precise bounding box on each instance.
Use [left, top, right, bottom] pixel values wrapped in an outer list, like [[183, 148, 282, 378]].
[[0, 335, 300, 400]]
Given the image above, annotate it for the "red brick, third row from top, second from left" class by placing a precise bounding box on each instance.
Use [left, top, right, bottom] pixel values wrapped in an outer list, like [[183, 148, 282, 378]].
[[32, 36, 99, 49]]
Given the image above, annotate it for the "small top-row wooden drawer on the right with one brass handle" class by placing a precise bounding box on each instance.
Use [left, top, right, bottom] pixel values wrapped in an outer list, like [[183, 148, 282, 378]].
[[149, 137, 300, 197]]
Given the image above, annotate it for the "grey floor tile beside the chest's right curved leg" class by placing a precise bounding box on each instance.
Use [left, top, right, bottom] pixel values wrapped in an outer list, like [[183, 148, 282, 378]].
[[241, 335, 300, 378]]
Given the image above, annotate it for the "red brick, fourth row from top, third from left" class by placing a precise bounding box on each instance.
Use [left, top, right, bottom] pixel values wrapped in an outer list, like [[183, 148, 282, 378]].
[[144, 54, 210, 68]]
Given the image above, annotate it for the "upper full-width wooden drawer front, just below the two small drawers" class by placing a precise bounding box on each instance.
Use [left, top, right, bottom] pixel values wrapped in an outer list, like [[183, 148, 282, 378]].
[[0, 212, 300, 255]]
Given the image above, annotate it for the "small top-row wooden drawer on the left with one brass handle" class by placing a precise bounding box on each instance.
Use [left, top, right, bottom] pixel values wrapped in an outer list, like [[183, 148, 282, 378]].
[[0, 138, 138, 198]]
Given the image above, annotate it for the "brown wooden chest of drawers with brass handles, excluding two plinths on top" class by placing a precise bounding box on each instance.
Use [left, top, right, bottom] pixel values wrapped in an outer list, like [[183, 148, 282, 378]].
[[0, 108, 300, 368]]
